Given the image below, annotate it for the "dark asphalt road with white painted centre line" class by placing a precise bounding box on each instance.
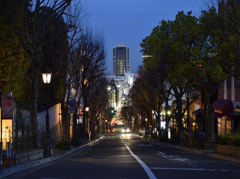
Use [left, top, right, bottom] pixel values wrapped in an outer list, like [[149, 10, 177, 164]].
[[5, 132, 240, 179]]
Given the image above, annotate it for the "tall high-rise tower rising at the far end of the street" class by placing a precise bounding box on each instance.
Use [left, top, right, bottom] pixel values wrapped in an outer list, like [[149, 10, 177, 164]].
[[113, 43, 129, 76]]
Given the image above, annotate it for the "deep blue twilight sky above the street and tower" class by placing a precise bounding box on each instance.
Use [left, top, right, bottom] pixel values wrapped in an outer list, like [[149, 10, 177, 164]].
[[83, 0, 204, 74]]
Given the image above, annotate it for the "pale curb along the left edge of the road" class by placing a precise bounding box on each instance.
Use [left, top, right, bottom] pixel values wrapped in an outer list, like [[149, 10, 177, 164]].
[[0, 136, 103, 178]]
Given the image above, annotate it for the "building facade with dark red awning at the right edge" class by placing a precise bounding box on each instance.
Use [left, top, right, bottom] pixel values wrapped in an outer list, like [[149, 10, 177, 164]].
[[212, 0, 240, 135]]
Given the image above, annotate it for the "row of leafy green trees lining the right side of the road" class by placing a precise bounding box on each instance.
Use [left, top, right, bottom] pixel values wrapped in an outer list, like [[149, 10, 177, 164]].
[[132, 0, 240, 141]]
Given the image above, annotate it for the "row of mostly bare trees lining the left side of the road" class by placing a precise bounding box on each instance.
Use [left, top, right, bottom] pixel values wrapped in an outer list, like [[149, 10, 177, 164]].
[[0, 0, 107, 151]]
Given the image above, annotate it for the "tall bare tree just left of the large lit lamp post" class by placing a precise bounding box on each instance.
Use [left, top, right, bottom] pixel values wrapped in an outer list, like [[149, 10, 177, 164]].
[[9, 0, 72, 148]]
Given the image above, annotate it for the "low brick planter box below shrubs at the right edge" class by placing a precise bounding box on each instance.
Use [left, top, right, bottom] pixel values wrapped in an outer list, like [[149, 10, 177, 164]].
[[214, 145, 240, 157]]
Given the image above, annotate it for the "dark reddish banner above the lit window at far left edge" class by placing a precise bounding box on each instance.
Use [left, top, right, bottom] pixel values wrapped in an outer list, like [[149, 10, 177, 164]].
[[1, 94, 13, 119]]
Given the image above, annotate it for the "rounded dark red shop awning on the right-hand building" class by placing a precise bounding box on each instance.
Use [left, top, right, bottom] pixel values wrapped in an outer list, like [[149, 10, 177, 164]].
[[212, 99, 234, 117]]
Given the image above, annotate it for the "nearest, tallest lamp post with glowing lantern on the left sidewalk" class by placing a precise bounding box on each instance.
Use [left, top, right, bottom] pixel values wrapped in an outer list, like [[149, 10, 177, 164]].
[[42, 68, 52, 156]]
